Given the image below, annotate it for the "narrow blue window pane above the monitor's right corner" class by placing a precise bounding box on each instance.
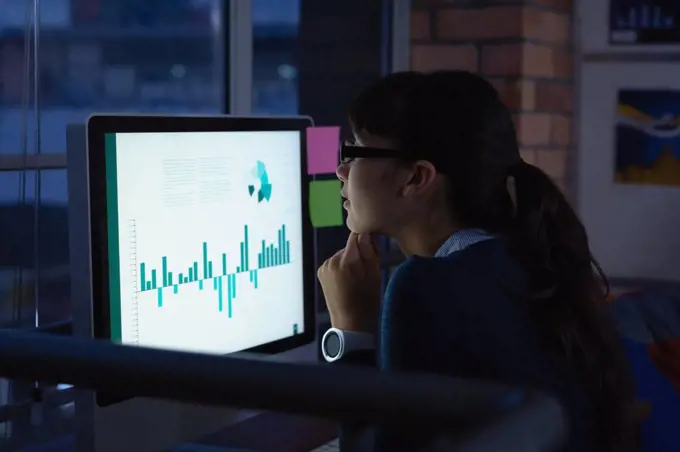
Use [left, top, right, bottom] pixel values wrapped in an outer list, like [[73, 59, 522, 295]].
[[252, 0, 300, 115]]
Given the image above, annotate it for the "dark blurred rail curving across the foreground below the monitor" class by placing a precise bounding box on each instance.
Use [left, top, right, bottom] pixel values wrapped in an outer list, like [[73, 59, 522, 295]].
[[0, 331, 566, 451]]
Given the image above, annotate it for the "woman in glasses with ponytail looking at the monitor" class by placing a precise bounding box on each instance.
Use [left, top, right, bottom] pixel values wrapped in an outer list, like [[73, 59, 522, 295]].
[[318, 71, 638, 452]]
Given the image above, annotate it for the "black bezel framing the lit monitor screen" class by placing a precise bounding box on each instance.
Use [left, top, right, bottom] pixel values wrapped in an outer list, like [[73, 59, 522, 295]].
[[87, 115, 316, 406]]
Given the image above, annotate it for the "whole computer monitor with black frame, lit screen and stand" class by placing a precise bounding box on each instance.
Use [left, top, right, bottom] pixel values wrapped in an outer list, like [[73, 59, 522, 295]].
[[68, 115, 316, 451]]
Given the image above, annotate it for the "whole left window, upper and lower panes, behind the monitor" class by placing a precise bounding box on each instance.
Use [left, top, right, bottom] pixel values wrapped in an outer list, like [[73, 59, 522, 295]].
[[0, 0, 229, 326]]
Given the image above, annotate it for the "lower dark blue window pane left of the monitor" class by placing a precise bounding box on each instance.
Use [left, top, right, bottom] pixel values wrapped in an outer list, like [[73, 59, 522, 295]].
[[0, 170, 71, 327]]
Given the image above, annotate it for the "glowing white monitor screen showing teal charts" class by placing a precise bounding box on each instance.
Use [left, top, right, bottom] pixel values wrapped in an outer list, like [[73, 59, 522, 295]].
[[99, 130, 305, 354]]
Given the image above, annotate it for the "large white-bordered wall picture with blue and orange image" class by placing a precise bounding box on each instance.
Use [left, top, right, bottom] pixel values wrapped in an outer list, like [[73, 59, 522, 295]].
[[575, 62, 680, 282]]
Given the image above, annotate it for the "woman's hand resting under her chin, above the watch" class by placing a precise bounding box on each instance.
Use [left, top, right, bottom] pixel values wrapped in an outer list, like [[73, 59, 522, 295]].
[[317, 232, 380, 333]]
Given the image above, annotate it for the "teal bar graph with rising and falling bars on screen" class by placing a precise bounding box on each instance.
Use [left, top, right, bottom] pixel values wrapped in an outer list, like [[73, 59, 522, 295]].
[[139, 225, 290, 317]]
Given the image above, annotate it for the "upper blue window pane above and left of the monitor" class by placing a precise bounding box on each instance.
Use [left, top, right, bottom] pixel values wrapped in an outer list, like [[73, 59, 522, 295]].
[[0, 0, 225, 154]]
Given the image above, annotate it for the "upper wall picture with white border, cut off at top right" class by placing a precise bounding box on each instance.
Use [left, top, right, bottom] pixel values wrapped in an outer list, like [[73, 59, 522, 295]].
[[577, 0, 680, 54]]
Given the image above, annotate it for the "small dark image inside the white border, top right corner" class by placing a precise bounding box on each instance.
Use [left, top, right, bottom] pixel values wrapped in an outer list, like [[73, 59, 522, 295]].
[[609, 0, 680, 45]]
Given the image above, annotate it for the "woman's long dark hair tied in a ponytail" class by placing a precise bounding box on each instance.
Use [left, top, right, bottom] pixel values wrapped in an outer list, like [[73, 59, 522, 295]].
[[350, 71, 638, 452]]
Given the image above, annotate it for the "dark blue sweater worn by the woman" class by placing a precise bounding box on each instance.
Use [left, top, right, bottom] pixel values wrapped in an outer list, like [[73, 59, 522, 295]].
[[341, 239, 592, 452]]
